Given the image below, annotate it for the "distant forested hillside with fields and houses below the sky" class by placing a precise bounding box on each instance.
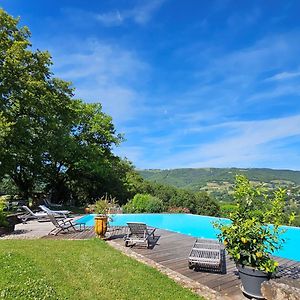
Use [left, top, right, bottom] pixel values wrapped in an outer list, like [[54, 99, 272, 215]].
[[139, 168, 300, 226]]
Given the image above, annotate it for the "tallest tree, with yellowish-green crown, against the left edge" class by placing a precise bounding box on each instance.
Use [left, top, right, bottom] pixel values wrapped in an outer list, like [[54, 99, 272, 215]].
[[0, 10, 65, 197]]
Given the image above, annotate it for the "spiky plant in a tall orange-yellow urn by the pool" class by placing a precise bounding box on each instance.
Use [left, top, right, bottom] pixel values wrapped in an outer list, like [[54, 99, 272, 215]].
[[94, 195, 115, 238]]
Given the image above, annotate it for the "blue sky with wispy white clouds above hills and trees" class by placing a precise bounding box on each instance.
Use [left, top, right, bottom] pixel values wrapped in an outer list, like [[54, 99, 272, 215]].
[[0, 0, 300, 170]]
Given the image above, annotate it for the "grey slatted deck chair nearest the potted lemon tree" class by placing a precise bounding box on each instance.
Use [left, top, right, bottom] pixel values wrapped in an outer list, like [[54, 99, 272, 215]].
[[188, 239, 224, 272]]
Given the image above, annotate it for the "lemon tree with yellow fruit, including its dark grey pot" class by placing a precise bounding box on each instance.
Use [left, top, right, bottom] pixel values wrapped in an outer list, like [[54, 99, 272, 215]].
[[214, 175, 286, 299]]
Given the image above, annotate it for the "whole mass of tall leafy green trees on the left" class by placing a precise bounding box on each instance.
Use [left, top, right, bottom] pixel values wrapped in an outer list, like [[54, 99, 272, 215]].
[[0, 10, 133, 204]]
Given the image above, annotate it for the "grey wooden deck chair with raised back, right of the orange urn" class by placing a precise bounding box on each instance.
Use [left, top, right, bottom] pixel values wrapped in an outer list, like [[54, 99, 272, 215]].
[[124, 222, 156, 248]]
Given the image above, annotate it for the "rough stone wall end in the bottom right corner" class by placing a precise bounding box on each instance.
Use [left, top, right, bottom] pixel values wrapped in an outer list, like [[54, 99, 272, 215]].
[[261, 279, 300, 300]]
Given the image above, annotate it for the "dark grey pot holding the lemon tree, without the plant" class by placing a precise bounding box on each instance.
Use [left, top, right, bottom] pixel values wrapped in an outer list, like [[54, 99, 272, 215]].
[[237, 265, 270, 299]]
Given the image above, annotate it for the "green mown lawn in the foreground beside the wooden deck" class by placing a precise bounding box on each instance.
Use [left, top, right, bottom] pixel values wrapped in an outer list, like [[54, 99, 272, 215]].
[[0, 239, 199, 300]]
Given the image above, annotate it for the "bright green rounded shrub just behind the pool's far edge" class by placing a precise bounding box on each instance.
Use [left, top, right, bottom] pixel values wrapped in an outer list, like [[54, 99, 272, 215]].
[[123, 194, 163, 213]]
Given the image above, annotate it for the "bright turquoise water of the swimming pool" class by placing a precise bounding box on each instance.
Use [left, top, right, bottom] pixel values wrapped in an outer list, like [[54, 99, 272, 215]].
[[78, 214, 300, 261]]
